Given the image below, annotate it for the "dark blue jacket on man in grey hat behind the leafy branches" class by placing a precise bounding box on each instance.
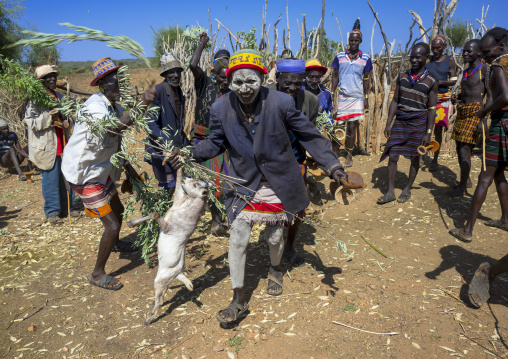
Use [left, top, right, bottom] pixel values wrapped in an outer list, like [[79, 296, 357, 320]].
[[145, 81, 190, 186]]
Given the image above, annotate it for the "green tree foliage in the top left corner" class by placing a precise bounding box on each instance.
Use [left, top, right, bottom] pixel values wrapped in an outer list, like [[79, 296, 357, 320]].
[[0, 0, 24, 61]]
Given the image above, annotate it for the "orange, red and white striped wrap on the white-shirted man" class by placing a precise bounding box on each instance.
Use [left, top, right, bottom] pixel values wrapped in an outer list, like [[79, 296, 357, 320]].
[[69, 177, 118, 218]]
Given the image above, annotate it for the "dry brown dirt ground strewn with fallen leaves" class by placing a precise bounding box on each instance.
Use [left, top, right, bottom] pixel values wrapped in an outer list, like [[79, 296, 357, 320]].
[[0, 150, 508, 359]]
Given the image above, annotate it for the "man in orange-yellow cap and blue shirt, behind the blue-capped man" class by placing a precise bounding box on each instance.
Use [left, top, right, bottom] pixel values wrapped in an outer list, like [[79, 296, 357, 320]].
[[302, 59, 333, 124]]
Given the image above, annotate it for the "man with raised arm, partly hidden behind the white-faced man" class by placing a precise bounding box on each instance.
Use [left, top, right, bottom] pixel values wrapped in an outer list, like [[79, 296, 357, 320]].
[[189, 33, 231, 233]]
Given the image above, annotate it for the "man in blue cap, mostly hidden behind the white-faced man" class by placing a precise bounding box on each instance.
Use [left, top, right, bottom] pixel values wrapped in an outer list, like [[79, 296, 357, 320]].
[[268, 59, 319, 267]]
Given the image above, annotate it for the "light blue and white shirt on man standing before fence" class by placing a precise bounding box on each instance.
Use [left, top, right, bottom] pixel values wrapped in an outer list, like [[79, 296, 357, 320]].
[[332, 51, 372, 98]]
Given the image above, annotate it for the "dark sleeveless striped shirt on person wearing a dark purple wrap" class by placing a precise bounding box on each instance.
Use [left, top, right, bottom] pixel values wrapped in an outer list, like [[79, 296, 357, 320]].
[[398, 71, 437, 112]]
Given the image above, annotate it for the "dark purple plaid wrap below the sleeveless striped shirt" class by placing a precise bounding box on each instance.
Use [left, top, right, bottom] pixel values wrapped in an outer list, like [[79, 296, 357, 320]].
[[379, 110, 427, 162]]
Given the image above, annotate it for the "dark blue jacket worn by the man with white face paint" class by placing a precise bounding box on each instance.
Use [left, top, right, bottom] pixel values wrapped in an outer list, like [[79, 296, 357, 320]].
[[191, 87, 340, 223]]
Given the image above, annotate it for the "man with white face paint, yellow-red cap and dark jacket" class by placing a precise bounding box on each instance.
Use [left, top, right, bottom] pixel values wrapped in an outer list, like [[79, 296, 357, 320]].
[[171, 49, 347, 323]]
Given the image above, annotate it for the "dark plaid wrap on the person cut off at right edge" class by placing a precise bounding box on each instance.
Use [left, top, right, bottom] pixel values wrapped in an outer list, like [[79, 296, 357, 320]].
[[485, 117, 508, 167]]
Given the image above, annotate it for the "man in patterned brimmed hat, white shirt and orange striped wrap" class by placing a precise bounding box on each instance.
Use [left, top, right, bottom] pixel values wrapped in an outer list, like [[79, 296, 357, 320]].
[[62, 57, 155, 290]]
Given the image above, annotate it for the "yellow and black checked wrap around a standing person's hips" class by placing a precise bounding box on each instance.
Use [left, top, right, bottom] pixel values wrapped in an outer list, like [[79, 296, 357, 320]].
[[452, 102, 481, 145]]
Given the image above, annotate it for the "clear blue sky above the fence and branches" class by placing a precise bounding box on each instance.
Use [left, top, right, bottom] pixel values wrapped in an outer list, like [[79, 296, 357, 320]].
[[19, 0, 508, 61]]
